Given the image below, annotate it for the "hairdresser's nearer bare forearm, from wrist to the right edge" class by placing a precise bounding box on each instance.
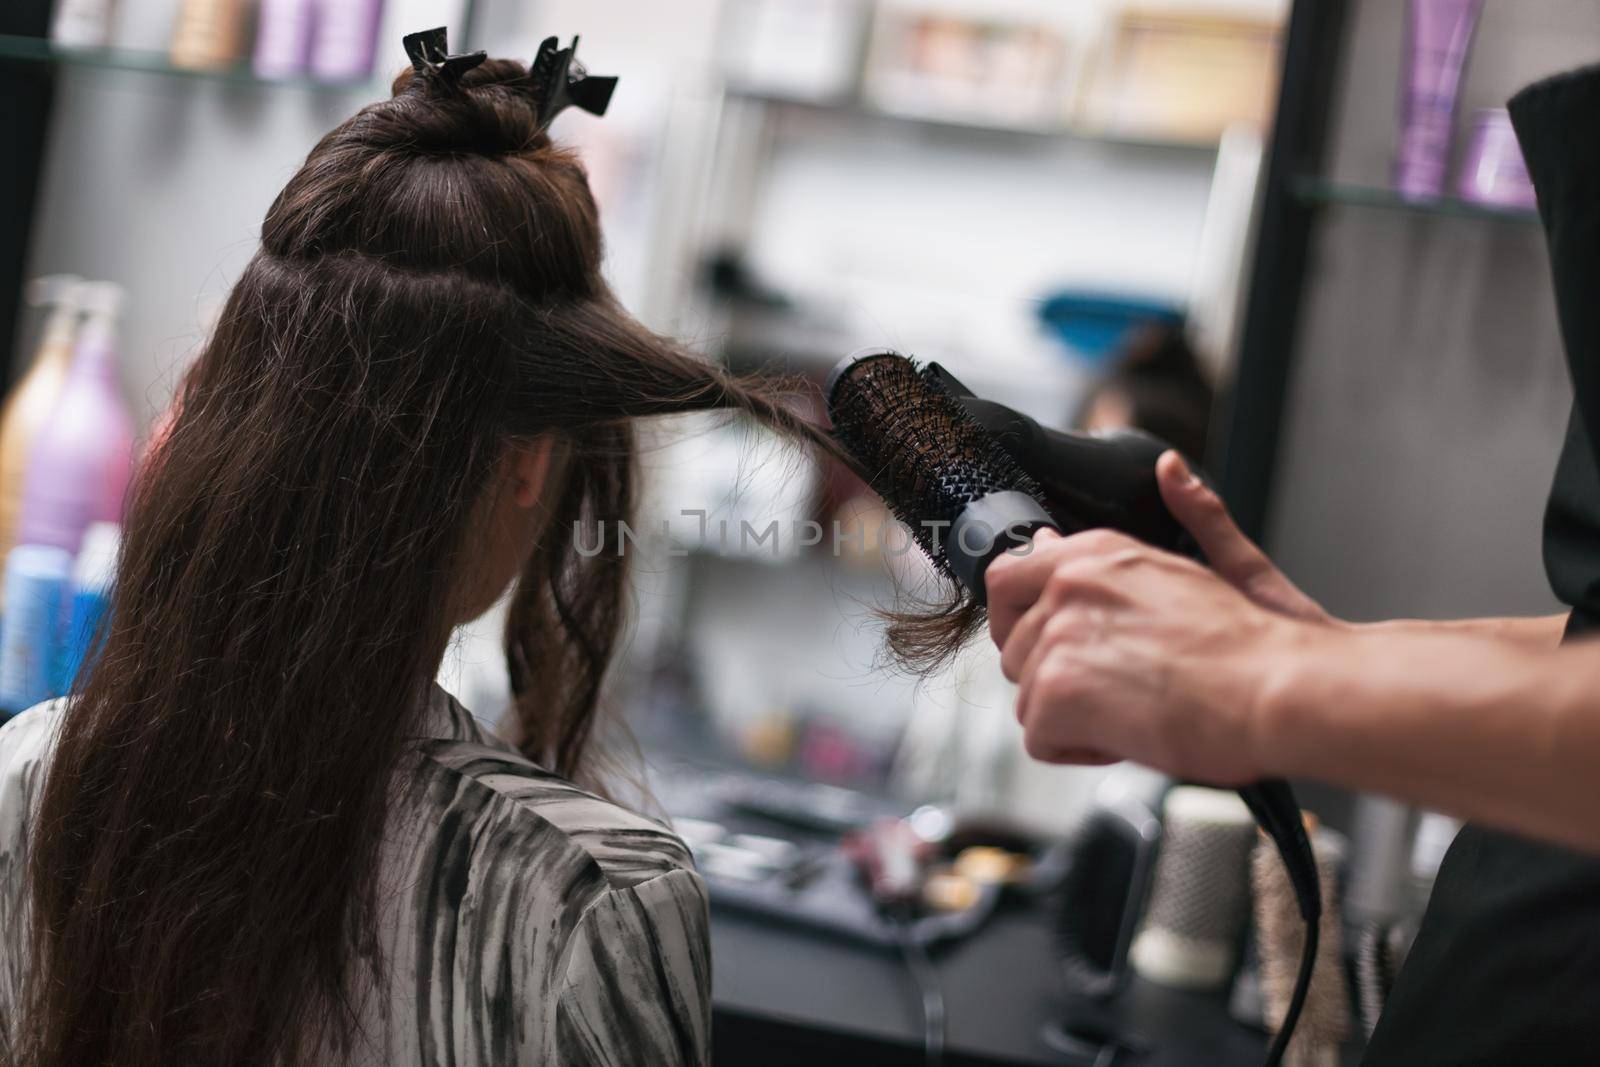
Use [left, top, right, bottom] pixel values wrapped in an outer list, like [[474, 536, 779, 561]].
[[1258, 629, 1600, 851]]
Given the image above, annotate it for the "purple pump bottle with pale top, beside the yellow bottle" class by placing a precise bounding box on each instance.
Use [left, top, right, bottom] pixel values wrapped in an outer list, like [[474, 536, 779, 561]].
[[16, 282, 133, 555]]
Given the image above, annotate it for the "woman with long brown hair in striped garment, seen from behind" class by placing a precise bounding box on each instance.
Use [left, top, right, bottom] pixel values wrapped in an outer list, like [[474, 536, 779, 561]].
[[0, 35, 827, 1067]]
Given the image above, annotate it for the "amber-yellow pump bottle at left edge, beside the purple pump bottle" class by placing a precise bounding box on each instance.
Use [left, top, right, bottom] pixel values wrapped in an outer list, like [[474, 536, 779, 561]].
[[0, 274, 83, 560]]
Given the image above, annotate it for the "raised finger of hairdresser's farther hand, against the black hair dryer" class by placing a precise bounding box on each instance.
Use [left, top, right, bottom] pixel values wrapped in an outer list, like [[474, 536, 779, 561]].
[[1155, 451, 1338, 625]]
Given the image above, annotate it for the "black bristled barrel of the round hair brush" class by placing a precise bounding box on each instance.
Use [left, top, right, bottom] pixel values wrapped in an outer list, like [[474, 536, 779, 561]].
[[826, 349, 1043, 577]]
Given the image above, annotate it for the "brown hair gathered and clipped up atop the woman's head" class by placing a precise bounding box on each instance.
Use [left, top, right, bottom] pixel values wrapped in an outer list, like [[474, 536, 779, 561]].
[[261, 59, 602, 292]]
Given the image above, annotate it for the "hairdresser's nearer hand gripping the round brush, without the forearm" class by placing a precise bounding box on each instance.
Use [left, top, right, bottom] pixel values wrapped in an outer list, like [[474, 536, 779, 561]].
[[984, 531, 1312, 785]]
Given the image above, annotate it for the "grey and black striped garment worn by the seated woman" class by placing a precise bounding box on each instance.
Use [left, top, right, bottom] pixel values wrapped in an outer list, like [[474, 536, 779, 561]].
[[0, 686, 710, 1067]]
